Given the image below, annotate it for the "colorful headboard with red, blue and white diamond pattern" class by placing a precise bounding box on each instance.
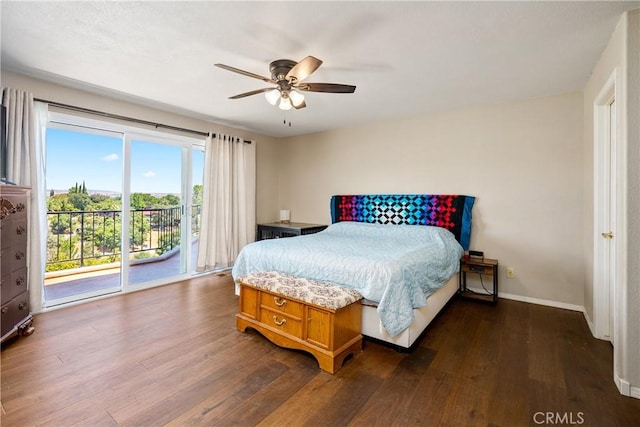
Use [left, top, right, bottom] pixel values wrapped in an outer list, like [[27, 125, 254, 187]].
[[331, 194, 475, 250]]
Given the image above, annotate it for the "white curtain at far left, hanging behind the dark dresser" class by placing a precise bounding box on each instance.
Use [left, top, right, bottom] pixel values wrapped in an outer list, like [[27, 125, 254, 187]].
[[2, 88, 48, 313]]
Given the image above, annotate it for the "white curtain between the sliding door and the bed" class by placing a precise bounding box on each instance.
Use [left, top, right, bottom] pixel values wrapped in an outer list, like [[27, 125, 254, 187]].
[[196, 135, 256, 271]]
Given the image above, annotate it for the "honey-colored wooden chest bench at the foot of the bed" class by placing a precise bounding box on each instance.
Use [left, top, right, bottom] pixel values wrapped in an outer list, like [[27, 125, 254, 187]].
[[236, 273, 362, 374]]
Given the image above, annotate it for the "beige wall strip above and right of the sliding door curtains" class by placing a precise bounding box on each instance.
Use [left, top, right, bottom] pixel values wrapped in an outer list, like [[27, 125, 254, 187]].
[[2, 70, 279, 222]]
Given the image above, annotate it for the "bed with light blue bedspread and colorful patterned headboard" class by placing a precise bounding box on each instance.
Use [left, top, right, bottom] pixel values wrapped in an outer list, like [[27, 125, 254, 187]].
[[232, 194, 475, 348]]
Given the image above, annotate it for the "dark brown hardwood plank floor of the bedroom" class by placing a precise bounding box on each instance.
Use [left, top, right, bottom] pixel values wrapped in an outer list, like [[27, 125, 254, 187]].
[[0, 275, 640, 427]]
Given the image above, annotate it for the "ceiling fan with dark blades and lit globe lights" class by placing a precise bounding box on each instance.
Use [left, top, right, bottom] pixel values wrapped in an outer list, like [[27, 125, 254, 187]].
[[215, 56, 356, 110]]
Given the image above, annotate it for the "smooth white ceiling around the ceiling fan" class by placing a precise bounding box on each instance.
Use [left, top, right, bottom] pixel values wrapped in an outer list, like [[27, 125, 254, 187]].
[[0, 1, 640, 136]]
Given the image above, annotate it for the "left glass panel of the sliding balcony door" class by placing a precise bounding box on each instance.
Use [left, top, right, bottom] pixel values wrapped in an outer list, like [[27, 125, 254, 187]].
[[43, 124, 123, 303]]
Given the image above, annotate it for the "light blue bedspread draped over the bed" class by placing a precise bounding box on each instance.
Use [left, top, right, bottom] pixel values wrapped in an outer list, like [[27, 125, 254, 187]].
[[232, 222, 463, 336]]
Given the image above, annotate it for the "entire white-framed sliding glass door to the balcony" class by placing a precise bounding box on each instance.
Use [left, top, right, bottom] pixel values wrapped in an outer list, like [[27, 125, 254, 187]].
[[44, 113, 204, 307]]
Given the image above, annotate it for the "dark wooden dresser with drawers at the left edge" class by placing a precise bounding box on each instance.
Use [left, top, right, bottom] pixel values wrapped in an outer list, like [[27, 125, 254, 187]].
[[0, 185, 33, 342]]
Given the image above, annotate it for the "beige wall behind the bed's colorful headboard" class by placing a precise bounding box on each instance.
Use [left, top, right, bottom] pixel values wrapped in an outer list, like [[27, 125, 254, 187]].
[[273, 93, 584, 307]]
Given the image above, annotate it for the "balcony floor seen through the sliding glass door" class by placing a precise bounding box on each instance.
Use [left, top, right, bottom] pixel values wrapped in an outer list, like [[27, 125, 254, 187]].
[[44, 241, 198, 301]]
